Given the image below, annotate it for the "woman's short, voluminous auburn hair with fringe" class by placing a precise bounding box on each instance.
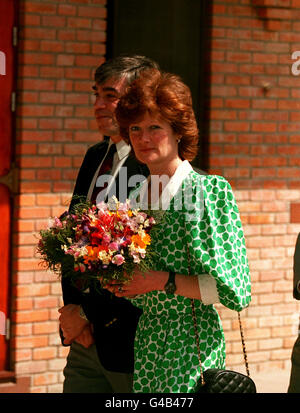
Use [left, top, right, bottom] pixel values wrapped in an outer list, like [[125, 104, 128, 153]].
[[116, 69, 198, 161]]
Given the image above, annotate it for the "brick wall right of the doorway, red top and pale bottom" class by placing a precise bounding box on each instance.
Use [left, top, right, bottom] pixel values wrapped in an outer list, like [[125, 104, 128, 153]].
[[207, 0, 300, 372]]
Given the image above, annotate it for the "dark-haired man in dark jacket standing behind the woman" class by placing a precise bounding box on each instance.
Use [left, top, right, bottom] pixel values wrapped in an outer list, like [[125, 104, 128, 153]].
[[59, 56, 158, 393]]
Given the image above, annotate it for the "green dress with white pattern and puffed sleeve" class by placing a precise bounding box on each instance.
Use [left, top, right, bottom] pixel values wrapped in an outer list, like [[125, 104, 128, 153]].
[[128, 171, 251, 393]]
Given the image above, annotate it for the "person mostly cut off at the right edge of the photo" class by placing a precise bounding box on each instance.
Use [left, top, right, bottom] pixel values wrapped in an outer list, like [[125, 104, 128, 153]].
[[288, 234, 300, 393]]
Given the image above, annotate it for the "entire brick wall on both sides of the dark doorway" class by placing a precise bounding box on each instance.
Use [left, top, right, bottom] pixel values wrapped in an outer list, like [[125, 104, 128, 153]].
[[6, 0, 300, 392]]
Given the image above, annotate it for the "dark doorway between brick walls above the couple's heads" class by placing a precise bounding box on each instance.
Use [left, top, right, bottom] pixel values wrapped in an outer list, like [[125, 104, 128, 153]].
[[106, 0, 212, 170]]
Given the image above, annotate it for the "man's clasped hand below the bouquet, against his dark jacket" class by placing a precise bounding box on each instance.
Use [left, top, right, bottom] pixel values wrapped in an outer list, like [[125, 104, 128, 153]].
[[58, 304, 89, 344]]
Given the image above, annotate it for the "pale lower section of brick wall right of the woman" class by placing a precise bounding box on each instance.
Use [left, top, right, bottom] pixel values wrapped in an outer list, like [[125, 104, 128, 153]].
[[219, 189, 300, 373]]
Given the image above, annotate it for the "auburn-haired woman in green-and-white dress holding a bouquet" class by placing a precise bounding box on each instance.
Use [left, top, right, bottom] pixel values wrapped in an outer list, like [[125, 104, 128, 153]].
[[105, 70, 251, 393]]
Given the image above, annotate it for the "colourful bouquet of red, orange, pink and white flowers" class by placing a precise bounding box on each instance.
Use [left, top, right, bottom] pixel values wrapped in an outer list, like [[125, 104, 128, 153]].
[[37, 197, 162, 289]]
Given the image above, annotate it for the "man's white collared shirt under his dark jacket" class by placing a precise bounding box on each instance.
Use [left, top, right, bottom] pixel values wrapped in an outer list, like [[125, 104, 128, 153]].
[[87, 139, 131, 200]]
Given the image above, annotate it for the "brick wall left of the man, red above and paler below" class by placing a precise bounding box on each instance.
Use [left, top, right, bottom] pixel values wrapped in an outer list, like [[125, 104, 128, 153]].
[[12, 0, 106, 392]]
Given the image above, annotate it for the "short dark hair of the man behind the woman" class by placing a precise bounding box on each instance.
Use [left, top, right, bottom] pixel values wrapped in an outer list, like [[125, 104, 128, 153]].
[[95, 55, 159, 85]]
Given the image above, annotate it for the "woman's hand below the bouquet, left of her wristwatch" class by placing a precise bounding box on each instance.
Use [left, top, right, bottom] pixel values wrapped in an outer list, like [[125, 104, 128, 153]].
[[104, 269, 168, 298]]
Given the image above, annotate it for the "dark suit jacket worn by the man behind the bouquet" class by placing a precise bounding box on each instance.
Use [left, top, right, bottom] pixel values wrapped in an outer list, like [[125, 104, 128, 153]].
[[62, 139, 149, 373]]
